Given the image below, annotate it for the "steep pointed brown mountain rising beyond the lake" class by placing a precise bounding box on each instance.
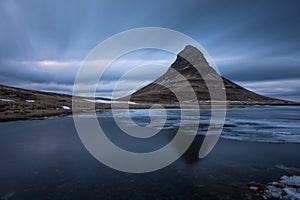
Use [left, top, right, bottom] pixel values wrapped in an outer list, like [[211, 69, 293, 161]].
[[123, 45, 292, 104]]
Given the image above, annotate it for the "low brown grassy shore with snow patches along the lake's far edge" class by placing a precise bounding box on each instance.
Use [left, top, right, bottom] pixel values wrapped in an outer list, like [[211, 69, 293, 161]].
[[0, 85, 300, 122]]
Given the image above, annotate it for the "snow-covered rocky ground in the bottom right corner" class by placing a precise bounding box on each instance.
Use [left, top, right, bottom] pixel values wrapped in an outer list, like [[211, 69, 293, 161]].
[[263, 175, 300, 200]]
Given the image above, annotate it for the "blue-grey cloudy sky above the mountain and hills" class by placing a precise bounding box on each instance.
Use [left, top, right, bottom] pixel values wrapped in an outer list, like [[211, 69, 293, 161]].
[[0, 0, 300, 101]]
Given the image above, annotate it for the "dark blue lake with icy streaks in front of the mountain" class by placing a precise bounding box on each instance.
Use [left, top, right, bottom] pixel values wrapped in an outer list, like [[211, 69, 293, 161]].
[[0, 107, 300, 200]]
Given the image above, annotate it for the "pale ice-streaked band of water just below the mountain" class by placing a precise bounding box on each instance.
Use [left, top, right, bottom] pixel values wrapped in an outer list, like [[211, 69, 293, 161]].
[[89, 106, 300, 143]]
